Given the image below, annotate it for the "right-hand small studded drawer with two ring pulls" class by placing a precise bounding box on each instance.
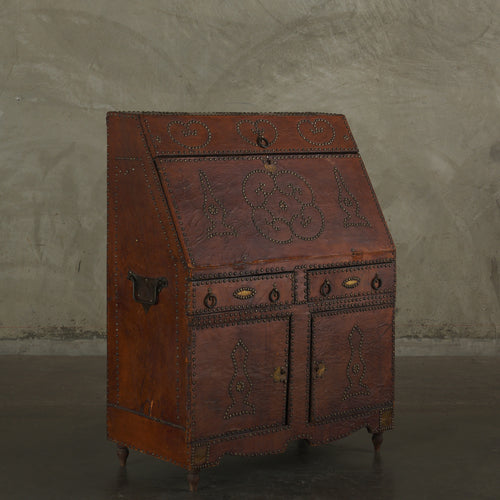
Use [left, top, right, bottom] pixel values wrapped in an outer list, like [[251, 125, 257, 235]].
[[307, 262, 396, 301]]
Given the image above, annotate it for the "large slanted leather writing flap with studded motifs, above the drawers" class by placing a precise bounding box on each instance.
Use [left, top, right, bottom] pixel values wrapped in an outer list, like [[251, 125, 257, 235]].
[[157, 155, 392, 268]]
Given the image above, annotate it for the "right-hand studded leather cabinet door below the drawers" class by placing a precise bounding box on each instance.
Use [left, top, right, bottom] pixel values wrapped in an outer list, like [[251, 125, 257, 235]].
[[309, 307, 394, 423]]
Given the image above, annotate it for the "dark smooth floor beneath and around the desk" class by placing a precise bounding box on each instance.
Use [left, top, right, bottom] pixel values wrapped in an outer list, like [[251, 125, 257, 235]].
[[0, 356, 500, 500]]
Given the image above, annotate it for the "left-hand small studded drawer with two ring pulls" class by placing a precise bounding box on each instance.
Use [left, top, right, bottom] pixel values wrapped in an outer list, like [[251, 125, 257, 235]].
[[190, 273, 294, 313]]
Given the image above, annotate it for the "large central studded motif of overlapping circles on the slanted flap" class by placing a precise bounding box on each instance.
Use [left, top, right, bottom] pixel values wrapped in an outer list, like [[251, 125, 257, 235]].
[[242, 170, 325, 244]]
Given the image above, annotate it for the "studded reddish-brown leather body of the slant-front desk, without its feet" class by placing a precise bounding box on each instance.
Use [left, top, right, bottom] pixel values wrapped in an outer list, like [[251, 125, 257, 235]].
[[107, 112, 396, 470]]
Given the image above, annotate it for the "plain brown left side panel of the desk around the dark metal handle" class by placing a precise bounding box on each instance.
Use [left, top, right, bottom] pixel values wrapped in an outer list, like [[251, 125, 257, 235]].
[[107, 113, 186, 446]]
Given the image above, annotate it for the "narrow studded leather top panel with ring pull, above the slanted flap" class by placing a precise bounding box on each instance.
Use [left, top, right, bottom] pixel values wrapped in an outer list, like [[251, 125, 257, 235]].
[[140, 113, 358, 157]]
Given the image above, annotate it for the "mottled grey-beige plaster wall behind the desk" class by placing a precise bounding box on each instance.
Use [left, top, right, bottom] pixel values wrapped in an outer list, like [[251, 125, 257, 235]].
[[0, 0, 500, 354]]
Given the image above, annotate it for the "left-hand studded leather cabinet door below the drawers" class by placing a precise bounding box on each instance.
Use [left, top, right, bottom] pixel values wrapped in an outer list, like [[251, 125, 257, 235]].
[[191, 316, 290, 440]]
